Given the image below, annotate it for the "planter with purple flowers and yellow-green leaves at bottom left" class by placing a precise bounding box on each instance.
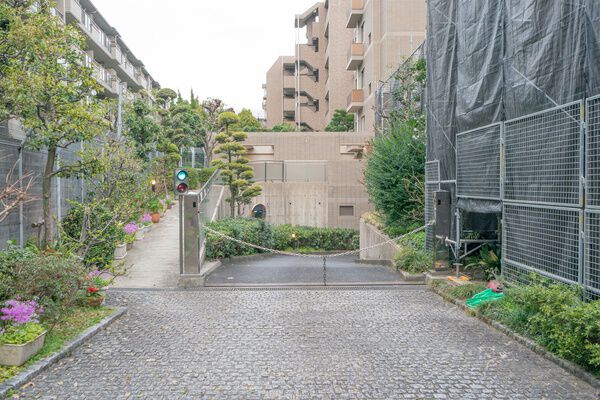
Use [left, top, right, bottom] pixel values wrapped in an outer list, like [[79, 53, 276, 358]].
[[0, 300, 46, 366]]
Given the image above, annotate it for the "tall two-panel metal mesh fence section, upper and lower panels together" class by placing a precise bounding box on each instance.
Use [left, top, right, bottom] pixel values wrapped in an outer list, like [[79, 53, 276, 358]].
[[503, 101, 585, 284]]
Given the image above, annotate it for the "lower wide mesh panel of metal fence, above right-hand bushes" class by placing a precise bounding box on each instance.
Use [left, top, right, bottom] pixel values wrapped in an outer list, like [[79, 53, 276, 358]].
[[503, 203, 580, 283]]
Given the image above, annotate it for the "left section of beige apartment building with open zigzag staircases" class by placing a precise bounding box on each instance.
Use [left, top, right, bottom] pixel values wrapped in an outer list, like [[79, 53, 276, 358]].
[[263, 0, 353, 131]]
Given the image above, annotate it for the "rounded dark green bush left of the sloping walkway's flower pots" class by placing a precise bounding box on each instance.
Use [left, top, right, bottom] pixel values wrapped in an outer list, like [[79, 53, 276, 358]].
[[61, 203, 123, 269]]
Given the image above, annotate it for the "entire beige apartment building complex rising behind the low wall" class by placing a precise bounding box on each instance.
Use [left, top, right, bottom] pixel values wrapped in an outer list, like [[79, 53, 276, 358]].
[[263, 0, 427, 135]]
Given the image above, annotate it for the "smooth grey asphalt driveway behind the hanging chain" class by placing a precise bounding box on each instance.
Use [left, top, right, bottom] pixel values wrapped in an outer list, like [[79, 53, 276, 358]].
[[206, 255, 405, 286]]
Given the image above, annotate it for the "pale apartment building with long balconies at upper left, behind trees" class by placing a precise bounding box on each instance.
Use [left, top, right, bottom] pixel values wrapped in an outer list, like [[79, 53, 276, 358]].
[[55, 0, 159, 98]]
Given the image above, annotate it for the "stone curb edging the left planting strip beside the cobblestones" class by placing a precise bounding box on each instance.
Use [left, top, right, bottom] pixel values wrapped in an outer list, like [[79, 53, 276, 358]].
[[0, 307, 127, 398]]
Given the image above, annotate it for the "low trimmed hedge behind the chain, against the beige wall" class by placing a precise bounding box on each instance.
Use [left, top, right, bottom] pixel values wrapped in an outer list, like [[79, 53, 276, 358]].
[[206, 218, 359, 259]]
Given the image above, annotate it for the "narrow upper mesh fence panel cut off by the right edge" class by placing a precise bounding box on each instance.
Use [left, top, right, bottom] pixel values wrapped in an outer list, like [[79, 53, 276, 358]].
[[586, 96, 600, 209]]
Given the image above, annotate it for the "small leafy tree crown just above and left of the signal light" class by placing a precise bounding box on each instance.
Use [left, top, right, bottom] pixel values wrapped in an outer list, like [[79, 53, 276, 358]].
[[123, 100, 161, 160]]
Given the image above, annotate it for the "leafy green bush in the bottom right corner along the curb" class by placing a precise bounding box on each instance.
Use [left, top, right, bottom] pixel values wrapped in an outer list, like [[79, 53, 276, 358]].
[[479, 282, 600, 374]]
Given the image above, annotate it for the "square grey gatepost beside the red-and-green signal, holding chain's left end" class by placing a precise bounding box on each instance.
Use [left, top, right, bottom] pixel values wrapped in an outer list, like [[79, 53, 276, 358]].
[[179, 192, 200, 275]]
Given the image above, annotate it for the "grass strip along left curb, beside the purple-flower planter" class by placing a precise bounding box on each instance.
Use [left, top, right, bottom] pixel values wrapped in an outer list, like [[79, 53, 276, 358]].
[[0, 308, 115, 382]]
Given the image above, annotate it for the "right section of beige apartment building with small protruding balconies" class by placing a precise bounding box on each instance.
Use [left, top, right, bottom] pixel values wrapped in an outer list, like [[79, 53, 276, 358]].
[[346, 0, 427, 133]]
